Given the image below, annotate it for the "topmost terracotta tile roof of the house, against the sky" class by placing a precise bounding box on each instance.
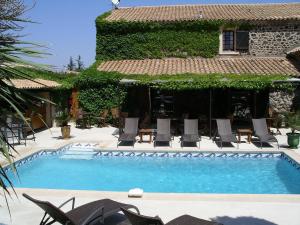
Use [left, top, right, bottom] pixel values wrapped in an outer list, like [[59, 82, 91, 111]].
[[106, 3, 300, 21]]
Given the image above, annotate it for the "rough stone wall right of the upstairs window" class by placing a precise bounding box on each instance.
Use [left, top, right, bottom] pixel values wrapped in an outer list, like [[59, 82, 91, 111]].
[[249, 22, 300, 56]]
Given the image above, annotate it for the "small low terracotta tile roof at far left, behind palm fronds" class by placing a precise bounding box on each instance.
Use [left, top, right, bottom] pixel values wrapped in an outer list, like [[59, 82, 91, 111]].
[[6, 79, 60, 89]]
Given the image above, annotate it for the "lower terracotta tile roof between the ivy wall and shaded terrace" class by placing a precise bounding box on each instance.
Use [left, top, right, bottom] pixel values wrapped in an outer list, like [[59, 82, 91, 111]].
[[98, 57, 300, 76]]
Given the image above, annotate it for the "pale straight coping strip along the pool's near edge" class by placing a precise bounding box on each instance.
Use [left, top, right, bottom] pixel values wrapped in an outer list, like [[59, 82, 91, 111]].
[[15, 188, 300, 204]]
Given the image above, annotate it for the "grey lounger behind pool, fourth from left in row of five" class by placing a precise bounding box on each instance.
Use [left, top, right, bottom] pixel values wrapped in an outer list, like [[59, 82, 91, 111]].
[[214, 119, 239, 148]]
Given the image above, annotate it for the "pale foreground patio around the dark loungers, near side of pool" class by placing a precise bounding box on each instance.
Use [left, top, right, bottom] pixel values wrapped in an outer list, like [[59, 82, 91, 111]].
[[0, 189, 300, 225]]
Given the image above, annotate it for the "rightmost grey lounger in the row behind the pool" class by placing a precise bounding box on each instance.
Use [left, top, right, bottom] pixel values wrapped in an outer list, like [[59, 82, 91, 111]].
[[252, 118, 279, 148]]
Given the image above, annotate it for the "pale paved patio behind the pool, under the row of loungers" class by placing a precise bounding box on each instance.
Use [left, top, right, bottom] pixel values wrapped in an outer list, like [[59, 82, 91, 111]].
[[1, 123, 300, 162]]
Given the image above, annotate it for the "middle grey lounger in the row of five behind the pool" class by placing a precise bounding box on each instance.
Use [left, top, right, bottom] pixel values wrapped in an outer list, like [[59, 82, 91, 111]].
[[154, 119, 172, 147]]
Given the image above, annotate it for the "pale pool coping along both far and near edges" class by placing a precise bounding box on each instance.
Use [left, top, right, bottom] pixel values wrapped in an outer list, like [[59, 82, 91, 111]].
[[3, 142, 300, 197]]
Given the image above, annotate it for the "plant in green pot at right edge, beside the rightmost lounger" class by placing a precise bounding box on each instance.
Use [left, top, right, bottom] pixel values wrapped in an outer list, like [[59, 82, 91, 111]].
[[286, 111, 300, 149]]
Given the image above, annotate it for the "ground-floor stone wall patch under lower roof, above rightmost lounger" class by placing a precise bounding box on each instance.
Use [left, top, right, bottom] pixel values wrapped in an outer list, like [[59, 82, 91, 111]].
[[269, 86, 300, 113]]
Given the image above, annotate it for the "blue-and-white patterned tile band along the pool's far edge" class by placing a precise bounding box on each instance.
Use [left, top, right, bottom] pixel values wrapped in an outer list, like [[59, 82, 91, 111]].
[[4, 143, 300, 171]]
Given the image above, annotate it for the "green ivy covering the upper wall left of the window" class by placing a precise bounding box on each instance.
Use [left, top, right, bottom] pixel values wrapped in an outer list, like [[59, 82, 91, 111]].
[[97, 30, 219, 60]]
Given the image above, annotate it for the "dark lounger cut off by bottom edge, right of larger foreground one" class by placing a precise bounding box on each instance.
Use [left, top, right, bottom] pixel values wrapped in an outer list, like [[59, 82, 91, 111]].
[[121, 208, 218, 225]]
